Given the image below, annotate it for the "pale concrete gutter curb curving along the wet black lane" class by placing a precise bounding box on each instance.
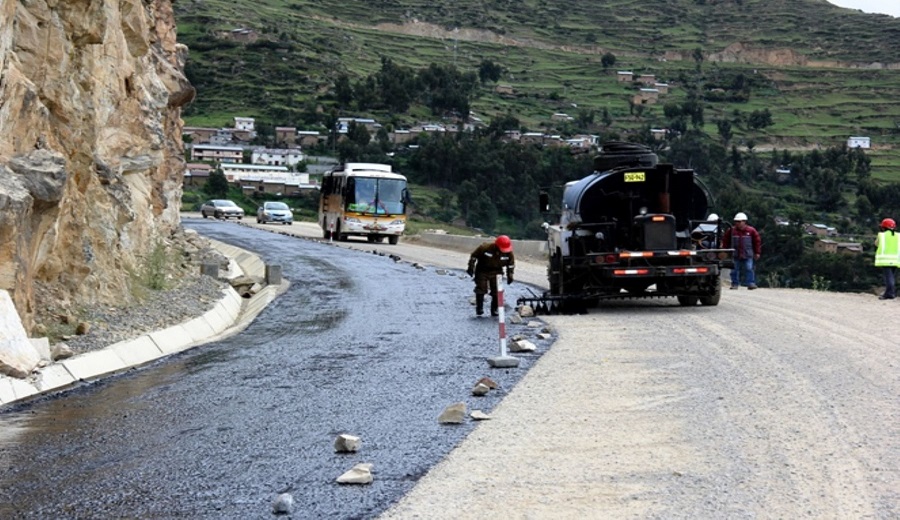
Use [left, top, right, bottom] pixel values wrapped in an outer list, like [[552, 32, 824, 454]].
[[0, 240, 290, 406]]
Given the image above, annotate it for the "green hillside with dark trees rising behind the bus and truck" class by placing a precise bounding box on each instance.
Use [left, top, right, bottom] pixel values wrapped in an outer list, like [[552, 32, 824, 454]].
[[175, 0, 900, 289]]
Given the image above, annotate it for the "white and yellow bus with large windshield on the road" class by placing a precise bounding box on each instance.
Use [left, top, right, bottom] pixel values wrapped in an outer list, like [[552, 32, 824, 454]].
[[319, 163, 409, 244]]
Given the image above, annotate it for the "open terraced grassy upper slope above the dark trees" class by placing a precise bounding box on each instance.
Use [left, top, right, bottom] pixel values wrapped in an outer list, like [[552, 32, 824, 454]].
[[176, 0, 900, 180]]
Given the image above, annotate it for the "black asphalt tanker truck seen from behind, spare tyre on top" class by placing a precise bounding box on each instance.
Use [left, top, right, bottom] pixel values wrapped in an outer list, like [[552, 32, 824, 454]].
[[518, 142, 733, 313]]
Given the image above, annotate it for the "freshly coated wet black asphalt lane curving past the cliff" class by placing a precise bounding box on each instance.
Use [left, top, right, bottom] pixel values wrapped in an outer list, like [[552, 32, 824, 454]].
[[0, 220, 549, 519]]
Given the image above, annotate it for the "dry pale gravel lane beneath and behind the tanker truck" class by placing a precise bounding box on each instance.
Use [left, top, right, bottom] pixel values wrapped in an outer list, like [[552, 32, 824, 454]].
[[234, 217, 900, 519]]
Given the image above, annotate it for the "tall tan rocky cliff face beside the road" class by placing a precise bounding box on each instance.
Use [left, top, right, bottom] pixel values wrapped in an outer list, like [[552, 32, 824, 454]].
[[0, 0, 194, 330]]
